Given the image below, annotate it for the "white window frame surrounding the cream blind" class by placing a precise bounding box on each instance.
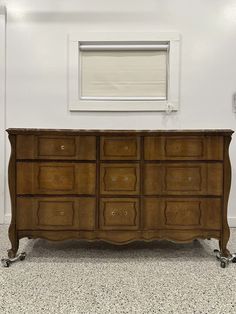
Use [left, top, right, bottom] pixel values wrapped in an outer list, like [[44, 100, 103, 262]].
[[68, 32, 180, 111]]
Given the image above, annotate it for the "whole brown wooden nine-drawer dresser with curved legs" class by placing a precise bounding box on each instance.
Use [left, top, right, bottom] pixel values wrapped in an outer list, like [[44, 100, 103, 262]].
[[7, 129, 233, 264]]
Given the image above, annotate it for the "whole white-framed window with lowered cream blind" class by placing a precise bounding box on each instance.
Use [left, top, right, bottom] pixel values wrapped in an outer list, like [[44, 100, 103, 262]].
[[69, 33, 179, 111]]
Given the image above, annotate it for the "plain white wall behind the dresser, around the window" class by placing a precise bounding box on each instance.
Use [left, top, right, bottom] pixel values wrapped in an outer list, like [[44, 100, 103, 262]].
[[1, 0, 236, 226]]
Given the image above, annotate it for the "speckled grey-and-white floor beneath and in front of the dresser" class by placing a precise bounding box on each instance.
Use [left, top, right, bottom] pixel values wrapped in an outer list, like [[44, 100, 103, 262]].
[[0, 225, 236, 314]]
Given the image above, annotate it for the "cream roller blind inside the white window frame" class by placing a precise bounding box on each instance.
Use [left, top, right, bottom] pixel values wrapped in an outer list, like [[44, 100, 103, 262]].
[[80, 45, 168, 100]]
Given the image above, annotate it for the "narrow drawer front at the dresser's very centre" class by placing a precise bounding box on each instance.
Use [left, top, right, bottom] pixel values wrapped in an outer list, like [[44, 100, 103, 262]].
[[100, 164, 139, 195]]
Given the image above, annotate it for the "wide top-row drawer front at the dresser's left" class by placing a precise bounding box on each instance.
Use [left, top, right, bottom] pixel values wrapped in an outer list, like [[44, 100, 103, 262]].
[[17, 135, 96, 160]]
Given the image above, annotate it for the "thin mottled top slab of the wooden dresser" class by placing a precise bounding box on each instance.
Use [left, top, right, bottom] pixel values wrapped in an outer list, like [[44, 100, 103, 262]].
[[6, 128, 234, 136]]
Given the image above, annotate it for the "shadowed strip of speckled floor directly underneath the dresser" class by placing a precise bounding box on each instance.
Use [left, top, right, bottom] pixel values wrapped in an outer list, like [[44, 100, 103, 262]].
[[21, 239, 217, 263]]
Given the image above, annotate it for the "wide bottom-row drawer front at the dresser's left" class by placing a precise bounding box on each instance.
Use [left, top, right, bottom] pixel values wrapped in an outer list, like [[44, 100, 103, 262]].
[[16, 197, 96, 230]]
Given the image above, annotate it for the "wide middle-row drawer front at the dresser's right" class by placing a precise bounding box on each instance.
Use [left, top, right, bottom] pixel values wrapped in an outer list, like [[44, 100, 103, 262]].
[[144, 163, 223, 196]]
